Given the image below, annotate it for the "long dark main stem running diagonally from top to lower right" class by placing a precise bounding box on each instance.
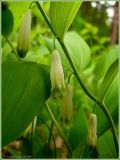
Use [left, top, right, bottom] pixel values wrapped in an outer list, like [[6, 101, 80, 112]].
[[35, 2, 118, 153]]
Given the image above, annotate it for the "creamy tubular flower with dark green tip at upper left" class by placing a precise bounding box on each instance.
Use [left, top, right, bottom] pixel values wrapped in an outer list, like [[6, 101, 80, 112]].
[[17, 9, 31, 58]]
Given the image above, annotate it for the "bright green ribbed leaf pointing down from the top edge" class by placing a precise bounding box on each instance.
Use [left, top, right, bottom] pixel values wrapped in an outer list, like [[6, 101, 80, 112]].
[[50, 0, 83, 38]]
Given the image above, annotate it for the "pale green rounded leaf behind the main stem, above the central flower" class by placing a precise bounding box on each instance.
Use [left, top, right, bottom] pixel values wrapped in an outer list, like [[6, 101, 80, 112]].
[[44, 32, 90, 71]]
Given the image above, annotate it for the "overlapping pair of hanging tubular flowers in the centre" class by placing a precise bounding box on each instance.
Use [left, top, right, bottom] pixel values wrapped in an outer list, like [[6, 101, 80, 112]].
[[50, 49, 73, 125]]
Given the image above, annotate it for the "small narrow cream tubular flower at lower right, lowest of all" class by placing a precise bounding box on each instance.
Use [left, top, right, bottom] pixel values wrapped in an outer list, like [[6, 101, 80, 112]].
[[88, 113, 97, 147]]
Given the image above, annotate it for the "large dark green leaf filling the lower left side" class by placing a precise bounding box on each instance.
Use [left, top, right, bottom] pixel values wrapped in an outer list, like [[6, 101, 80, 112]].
[[2, 61, 50, 146]]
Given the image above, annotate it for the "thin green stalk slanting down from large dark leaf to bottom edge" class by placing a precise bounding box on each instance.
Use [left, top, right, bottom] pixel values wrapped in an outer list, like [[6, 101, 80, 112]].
[[45, 102, 72, 157]]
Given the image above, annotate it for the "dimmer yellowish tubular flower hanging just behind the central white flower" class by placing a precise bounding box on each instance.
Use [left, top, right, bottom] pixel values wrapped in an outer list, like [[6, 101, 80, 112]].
[[60, 84, 73, 126]]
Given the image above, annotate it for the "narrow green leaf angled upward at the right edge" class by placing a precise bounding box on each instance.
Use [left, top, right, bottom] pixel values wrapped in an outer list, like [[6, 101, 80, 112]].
[[99, 59, 119, 101]]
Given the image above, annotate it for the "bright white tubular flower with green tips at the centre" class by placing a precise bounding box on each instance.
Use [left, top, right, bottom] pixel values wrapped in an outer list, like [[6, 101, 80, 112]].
[[50, 50, 66, 98]]
